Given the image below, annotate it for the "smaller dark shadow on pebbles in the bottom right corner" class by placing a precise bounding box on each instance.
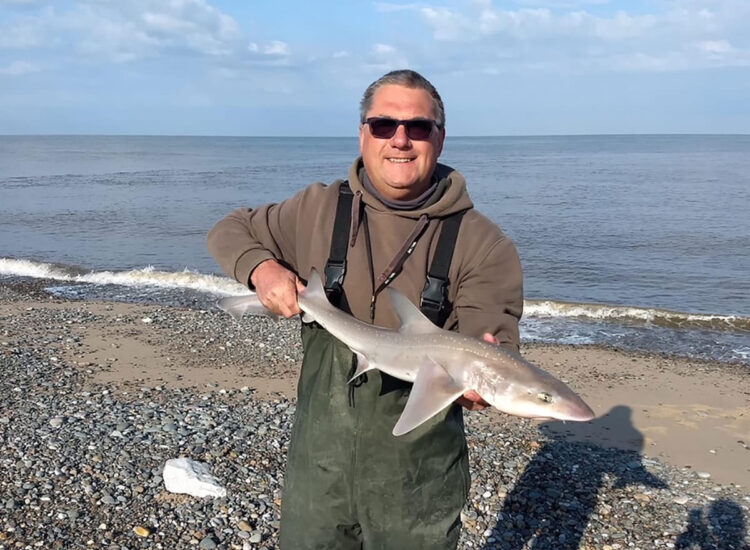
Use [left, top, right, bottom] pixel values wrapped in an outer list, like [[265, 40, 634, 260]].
[[675, 499, 750, 550]]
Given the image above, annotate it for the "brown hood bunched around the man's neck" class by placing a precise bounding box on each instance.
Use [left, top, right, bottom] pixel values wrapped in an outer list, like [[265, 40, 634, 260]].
[[349, 157, 474, 219]]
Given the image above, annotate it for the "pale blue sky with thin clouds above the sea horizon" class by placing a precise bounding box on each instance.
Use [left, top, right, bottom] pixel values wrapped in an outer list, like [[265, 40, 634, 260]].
[[0, 0, 750, 136]]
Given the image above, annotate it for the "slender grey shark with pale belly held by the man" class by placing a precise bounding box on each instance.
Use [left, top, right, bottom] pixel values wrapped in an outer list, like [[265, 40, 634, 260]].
[[217, 269, 595, 436]]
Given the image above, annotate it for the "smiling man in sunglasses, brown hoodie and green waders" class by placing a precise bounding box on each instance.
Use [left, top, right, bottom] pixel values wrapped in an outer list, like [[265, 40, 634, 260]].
[[208, 71, 523, 550]]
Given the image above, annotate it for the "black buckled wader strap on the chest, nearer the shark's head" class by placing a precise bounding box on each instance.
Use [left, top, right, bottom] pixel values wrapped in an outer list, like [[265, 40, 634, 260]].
[[419, 210, 466, 328]]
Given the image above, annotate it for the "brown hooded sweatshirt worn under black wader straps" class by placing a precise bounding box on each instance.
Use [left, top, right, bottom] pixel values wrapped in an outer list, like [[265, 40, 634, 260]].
[[208, 159, 523, 350]]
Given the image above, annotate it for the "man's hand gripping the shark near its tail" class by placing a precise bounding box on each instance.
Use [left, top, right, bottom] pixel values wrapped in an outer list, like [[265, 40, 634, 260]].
[[250, 260, 305, 318]]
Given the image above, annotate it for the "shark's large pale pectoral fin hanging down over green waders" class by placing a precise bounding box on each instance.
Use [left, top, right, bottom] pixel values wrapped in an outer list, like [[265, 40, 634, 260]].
[[393, 361, 465, 436]]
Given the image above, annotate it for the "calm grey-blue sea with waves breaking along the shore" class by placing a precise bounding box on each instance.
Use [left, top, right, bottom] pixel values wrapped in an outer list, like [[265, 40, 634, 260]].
[[0, 135, 750, 366]]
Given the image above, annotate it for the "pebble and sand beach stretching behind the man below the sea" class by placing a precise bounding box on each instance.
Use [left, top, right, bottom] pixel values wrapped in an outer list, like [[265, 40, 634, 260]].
[[0, 280, 750, 550]]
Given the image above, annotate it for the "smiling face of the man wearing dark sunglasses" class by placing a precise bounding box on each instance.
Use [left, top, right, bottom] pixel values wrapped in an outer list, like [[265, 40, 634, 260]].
[[359, 84, 445, 200]]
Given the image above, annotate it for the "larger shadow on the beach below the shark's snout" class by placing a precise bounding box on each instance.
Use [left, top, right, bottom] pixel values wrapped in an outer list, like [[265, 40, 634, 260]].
[[483, 405, 666, 550]]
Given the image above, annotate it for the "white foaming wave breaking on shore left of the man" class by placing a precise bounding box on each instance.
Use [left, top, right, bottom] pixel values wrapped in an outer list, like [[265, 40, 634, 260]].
[[0, 258, 247, 295]]
